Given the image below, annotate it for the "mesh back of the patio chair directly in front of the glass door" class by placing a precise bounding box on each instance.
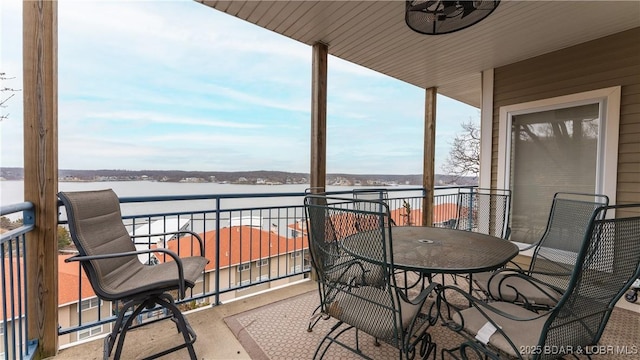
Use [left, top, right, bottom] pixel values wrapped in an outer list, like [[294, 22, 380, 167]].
[[529, 192, 609, 289]]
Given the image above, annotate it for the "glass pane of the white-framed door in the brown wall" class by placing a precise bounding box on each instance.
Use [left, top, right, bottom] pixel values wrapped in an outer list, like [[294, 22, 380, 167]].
[[509, 103, 601, 243]]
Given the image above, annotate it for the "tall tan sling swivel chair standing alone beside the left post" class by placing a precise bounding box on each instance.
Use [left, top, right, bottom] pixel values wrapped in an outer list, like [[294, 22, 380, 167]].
[[58, 189, 208, 360]]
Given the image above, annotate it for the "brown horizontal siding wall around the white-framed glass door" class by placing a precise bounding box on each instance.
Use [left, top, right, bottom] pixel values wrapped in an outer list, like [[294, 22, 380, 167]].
[[491, 27, 640, 204]]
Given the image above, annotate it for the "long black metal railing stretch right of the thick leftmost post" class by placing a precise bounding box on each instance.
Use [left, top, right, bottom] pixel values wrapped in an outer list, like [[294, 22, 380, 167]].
[[58, 188, 425, 344]]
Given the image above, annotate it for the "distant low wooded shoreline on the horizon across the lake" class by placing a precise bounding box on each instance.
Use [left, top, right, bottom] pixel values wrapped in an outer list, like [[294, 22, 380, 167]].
[[0, 167, 477, 186]]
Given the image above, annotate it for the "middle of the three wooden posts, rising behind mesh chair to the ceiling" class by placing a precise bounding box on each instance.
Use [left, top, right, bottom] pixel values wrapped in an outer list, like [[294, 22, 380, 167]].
[[310, 42, 329, 192]]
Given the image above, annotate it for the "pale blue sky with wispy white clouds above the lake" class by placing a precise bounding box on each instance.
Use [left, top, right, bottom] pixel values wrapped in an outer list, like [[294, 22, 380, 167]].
[[0, 0, 480, 174]]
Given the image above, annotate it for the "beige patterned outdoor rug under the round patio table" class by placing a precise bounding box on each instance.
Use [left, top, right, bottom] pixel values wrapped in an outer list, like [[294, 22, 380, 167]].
[[225, 291, 640, 360]]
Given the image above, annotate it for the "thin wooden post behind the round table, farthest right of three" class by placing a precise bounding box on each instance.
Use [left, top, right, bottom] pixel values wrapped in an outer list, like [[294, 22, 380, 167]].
[[422, 87, 438, 226]]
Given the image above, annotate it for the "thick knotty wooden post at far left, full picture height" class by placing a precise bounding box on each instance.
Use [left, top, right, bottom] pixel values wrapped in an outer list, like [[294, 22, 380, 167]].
[[22, 0, 58, 358]]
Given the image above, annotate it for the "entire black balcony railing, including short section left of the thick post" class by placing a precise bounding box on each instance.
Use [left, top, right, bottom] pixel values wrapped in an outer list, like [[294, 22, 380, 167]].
[[1, 187, 484, 358]]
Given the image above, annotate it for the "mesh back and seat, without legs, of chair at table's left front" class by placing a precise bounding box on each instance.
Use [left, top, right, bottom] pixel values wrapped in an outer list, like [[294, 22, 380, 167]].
[[305, 196, 404, 347]]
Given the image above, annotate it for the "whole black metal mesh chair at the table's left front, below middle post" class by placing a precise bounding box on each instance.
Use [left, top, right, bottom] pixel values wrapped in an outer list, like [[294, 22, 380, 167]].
[[305, 195, 435, 359]]
